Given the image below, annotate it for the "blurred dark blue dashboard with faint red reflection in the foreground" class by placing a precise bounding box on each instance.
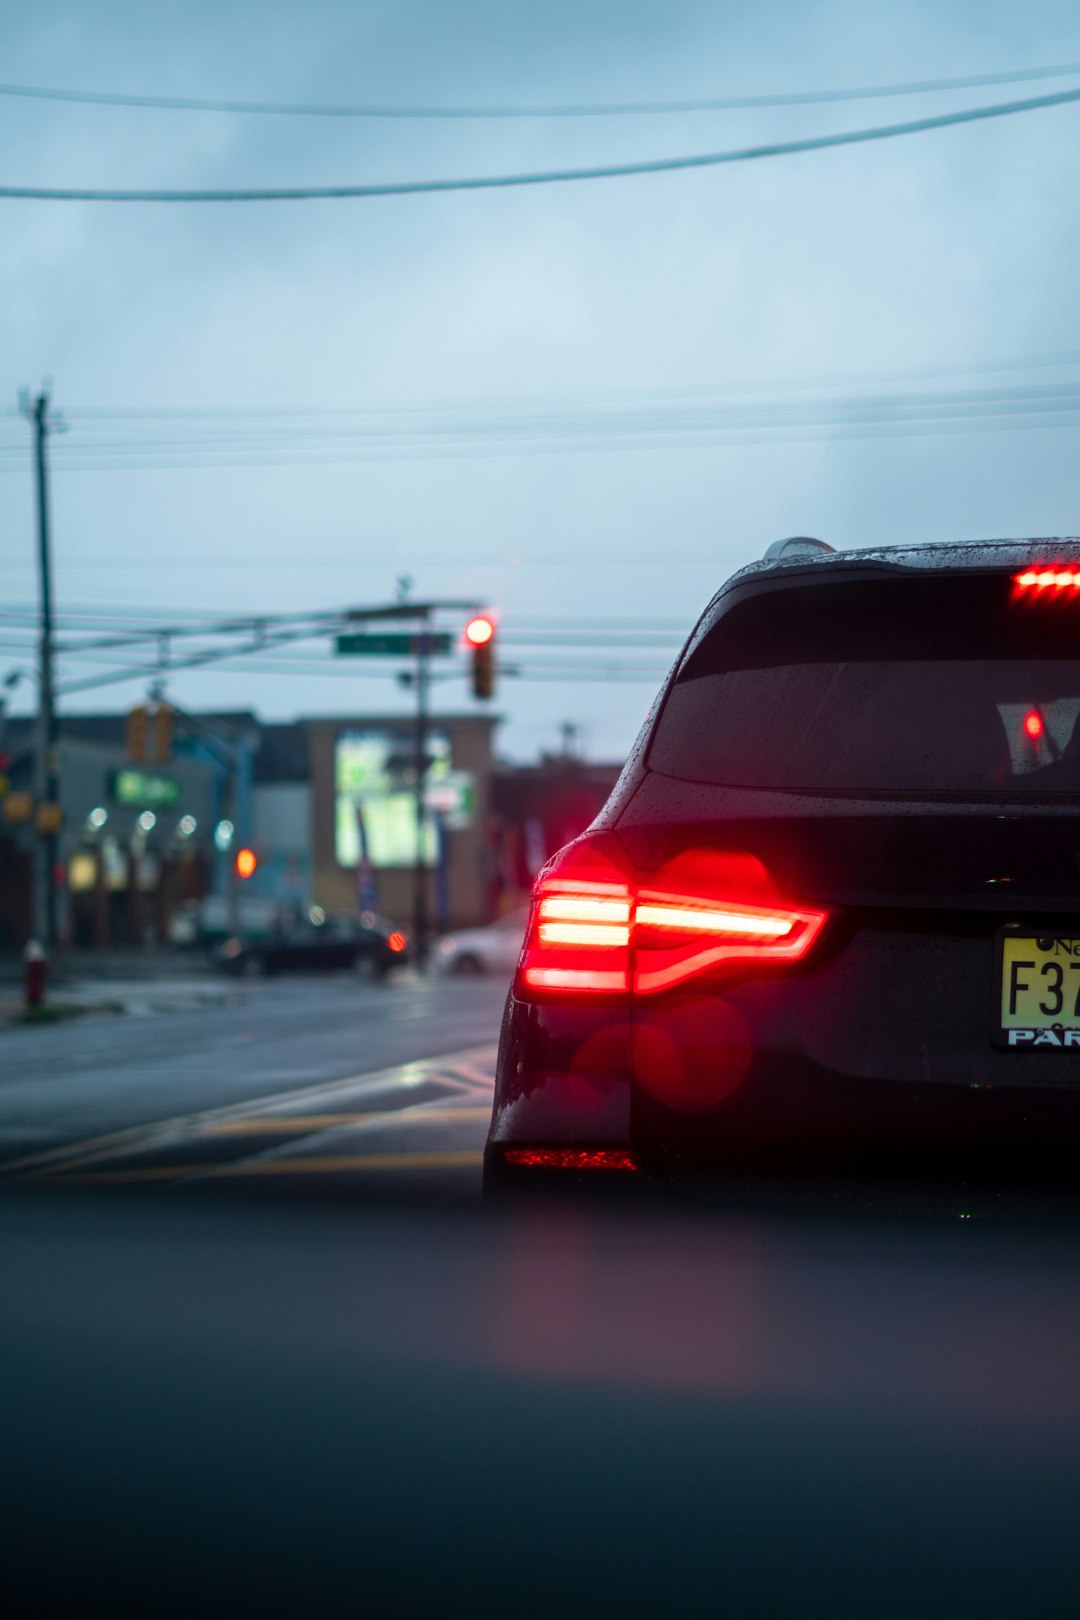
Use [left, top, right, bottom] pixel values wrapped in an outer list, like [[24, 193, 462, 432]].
[[0, 1194, 1080, 1620]]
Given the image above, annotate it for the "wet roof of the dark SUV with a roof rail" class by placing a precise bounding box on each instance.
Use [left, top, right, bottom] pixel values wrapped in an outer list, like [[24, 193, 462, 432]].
[[721, 535, 1080, 593]]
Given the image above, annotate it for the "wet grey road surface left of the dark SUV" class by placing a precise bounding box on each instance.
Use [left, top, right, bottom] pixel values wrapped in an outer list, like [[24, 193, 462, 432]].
[[0, 974, 505, 1197]]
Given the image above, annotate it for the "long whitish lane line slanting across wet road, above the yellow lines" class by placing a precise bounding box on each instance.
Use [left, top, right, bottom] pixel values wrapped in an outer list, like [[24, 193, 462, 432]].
[[0, 1042, 499, 1179]]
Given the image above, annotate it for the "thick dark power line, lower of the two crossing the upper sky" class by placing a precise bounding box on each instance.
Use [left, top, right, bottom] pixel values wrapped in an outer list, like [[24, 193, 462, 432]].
[[0, 89, 1080, 203]]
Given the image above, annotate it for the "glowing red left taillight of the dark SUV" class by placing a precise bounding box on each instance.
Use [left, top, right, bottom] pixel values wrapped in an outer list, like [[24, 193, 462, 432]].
[[517, 833, 827, 1000]]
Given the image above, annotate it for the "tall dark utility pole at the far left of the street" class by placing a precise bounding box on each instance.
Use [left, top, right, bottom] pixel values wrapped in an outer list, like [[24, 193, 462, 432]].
[[19, 387, 60, 951]]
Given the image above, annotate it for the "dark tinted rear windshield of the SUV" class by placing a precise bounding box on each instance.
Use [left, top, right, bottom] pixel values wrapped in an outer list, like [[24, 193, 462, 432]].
[[649, 575, 1080, 797]]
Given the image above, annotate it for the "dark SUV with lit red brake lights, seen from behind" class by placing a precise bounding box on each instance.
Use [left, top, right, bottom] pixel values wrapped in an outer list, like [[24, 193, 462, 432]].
[[486, 539, 1080, 1183]]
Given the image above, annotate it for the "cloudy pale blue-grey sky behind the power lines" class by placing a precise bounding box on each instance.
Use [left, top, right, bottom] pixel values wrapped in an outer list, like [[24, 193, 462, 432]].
[[0, 0, 1080, 758]]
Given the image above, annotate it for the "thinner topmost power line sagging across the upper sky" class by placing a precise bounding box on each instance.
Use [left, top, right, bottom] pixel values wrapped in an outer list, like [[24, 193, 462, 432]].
[[0, 62, 1080, 120]]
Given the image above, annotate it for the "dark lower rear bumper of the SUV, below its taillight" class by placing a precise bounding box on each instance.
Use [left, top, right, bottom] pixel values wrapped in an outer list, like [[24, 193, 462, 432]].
[[487, 985, 1080, 1173]]
